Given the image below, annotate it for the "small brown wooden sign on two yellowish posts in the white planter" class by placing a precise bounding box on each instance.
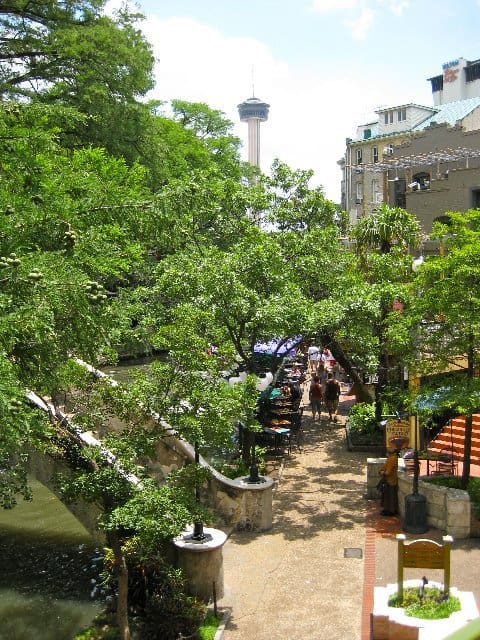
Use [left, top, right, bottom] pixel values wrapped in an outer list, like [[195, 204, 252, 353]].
[[397, 533, 453, 602]]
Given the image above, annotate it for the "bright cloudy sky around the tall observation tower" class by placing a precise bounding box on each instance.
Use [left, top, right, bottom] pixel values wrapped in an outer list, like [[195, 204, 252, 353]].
[[107, 0, 480, 202]]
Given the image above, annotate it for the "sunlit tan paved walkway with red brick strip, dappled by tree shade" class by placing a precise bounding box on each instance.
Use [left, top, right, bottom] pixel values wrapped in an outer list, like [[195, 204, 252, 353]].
[[218, 384, 480, 640]]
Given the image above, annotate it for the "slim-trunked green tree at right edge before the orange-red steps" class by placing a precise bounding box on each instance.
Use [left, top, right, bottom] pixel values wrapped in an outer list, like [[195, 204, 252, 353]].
[[406, 210, 480, 488]]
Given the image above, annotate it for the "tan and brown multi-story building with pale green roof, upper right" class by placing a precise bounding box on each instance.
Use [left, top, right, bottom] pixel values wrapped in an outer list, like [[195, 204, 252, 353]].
[[339, 58, 480, 231]]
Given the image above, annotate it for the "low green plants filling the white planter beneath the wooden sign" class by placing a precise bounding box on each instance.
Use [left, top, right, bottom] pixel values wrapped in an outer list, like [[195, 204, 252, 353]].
[[388, 587, 461, 620]]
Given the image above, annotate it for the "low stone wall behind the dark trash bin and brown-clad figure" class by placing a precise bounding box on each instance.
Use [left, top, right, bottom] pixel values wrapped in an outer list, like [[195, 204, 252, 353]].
[[367, 458, 472, 540]]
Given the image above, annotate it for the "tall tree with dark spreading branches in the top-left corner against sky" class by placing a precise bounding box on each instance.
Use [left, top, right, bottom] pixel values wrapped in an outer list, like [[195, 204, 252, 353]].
[[0, 0, 153, 164]]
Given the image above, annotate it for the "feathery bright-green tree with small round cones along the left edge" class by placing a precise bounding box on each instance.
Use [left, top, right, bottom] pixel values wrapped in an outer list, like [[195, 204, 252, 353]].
[[0, 104, 158, 504]]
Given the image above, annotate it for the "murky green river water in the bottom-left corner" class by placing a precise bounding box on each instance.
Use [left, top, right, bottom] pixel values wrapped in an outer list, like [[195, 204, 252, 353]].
[[0, 479, 102, 640]]
